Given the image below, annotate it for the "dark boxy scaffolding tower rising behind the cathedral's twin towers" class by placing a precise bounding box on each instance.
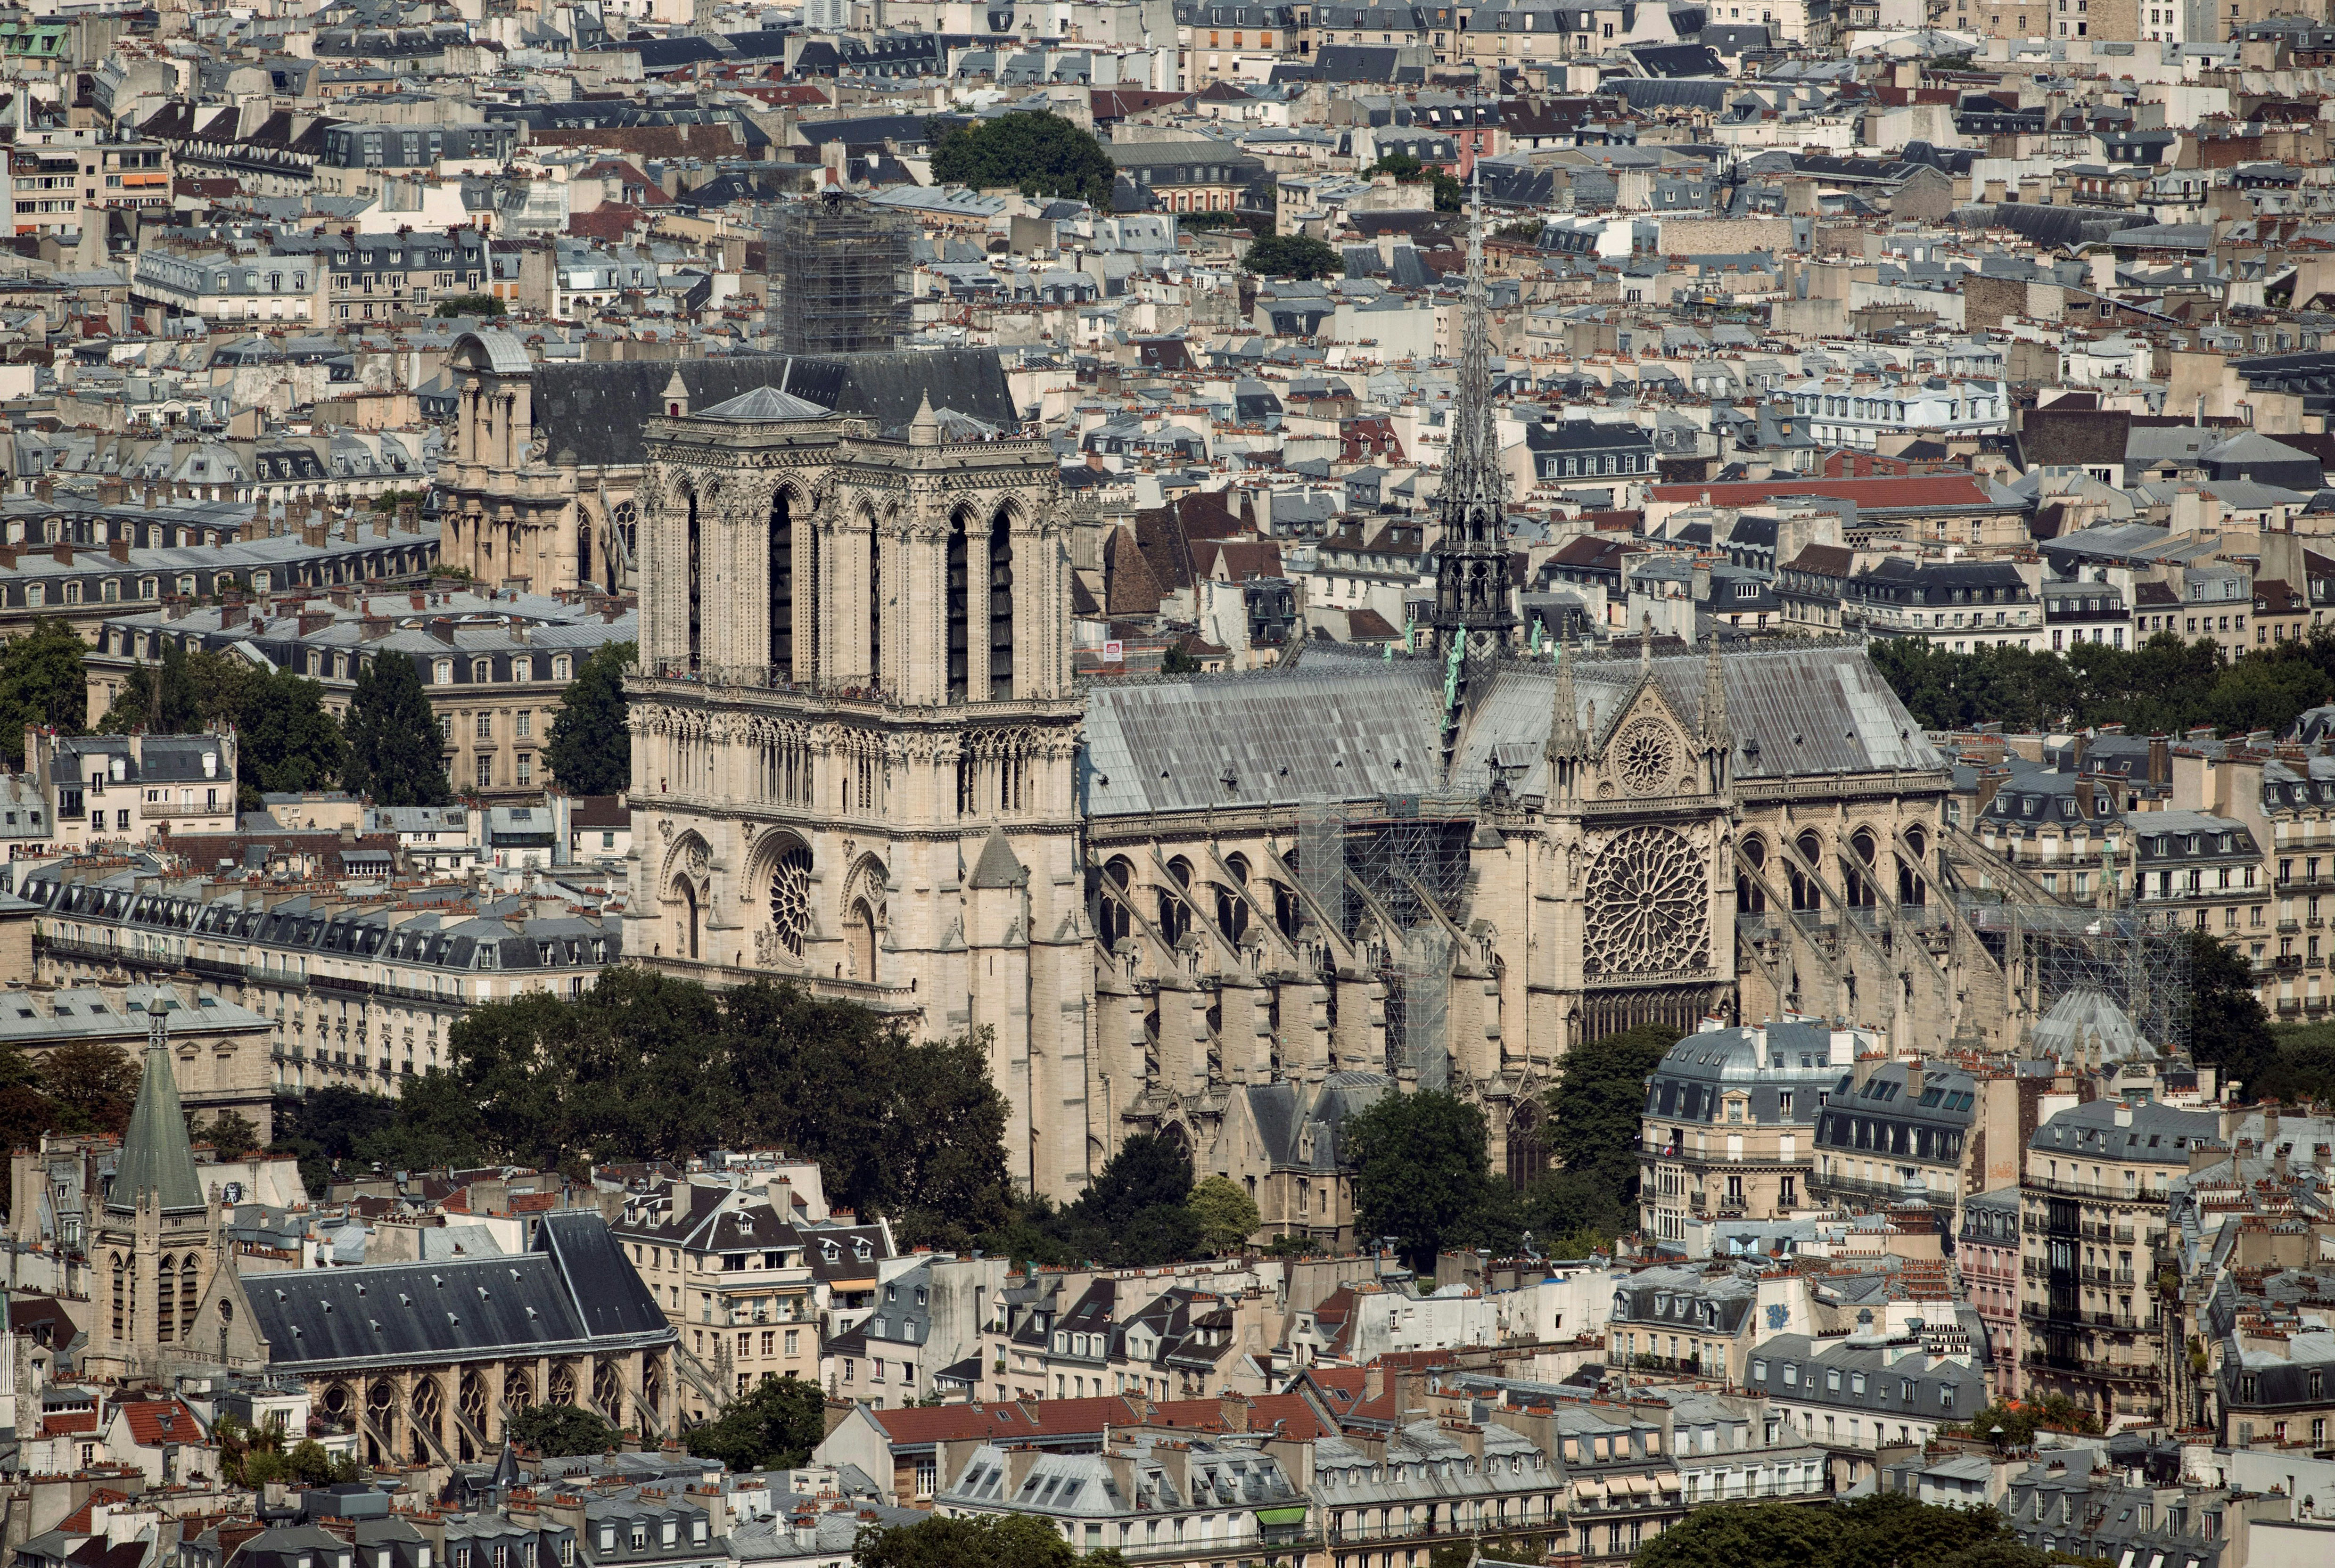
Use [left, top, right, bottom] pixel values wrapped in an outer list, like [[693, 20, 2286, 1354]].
[[771, 191, 913, 355]]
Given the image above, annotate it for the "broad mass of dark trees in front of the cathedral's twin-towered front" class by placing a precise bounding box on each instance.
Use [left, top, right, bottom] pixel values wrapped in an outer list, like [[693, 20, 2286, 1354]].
[[280, 969, 1016, 1246]]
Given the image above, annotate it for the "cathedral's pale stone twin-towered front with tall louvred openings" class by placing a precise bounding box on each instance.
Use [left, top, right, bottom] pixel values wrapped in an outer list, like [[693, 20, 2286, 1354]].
[[628, 371, 1091, 1190]]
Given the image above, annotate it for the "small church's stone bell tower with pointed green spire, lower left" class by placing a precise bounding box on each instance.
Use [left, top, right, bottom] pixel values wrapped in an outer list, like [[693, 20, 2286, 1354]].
[[86, 1003, 220, 1379]]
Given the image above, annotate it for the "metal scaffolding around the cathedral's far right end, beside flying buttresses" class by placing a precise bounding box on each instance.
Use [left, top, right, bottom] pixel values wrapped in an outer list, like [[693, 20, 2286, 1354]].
[[1961, 891, 2190, 1055]]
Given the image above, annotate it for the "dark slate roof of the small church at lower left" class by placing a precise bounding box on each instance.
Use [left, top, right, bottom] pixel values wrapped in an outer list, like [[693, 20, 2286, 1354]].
[[243, 1211, 677, 1374]]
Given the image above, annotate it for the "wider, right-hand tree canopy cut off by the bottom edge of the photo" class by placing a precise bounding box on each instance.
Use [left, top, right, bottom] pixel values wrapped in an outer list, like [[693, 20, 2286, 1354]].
[[1632, 1491, 2050, 1568]]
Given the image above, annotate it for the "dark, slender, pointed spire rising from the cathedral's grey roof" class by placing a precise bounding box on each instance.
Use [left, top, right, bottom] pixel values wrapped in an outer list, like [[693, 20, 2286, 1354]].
[[1434, 151, 1518, 656]]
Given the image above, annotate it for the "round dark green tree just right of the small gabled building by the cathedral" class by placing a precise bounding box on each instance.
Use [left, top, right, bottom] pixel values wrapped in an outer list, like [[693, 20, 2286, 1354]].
[[1343, 1090, 1520, 1274]]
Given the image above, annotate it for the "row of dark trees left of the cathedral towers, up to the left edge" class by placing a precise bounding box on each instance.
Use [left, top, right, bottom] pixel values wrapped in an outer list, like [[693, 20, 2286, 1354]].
[[23, 618, 633, 812]]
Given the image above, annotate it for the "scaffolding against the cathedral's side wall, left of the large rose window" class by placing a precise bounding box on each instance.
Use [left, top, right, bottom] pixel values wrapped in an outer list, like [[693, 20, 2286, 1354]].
[[1294, 793, 1478, 1090]]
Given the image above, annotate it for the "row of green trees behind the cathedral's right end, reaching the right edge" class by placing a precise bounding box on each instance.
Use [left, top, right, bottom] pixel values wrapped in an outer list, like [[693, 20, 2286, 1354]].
[[1870, 628, 2335, 735]]
